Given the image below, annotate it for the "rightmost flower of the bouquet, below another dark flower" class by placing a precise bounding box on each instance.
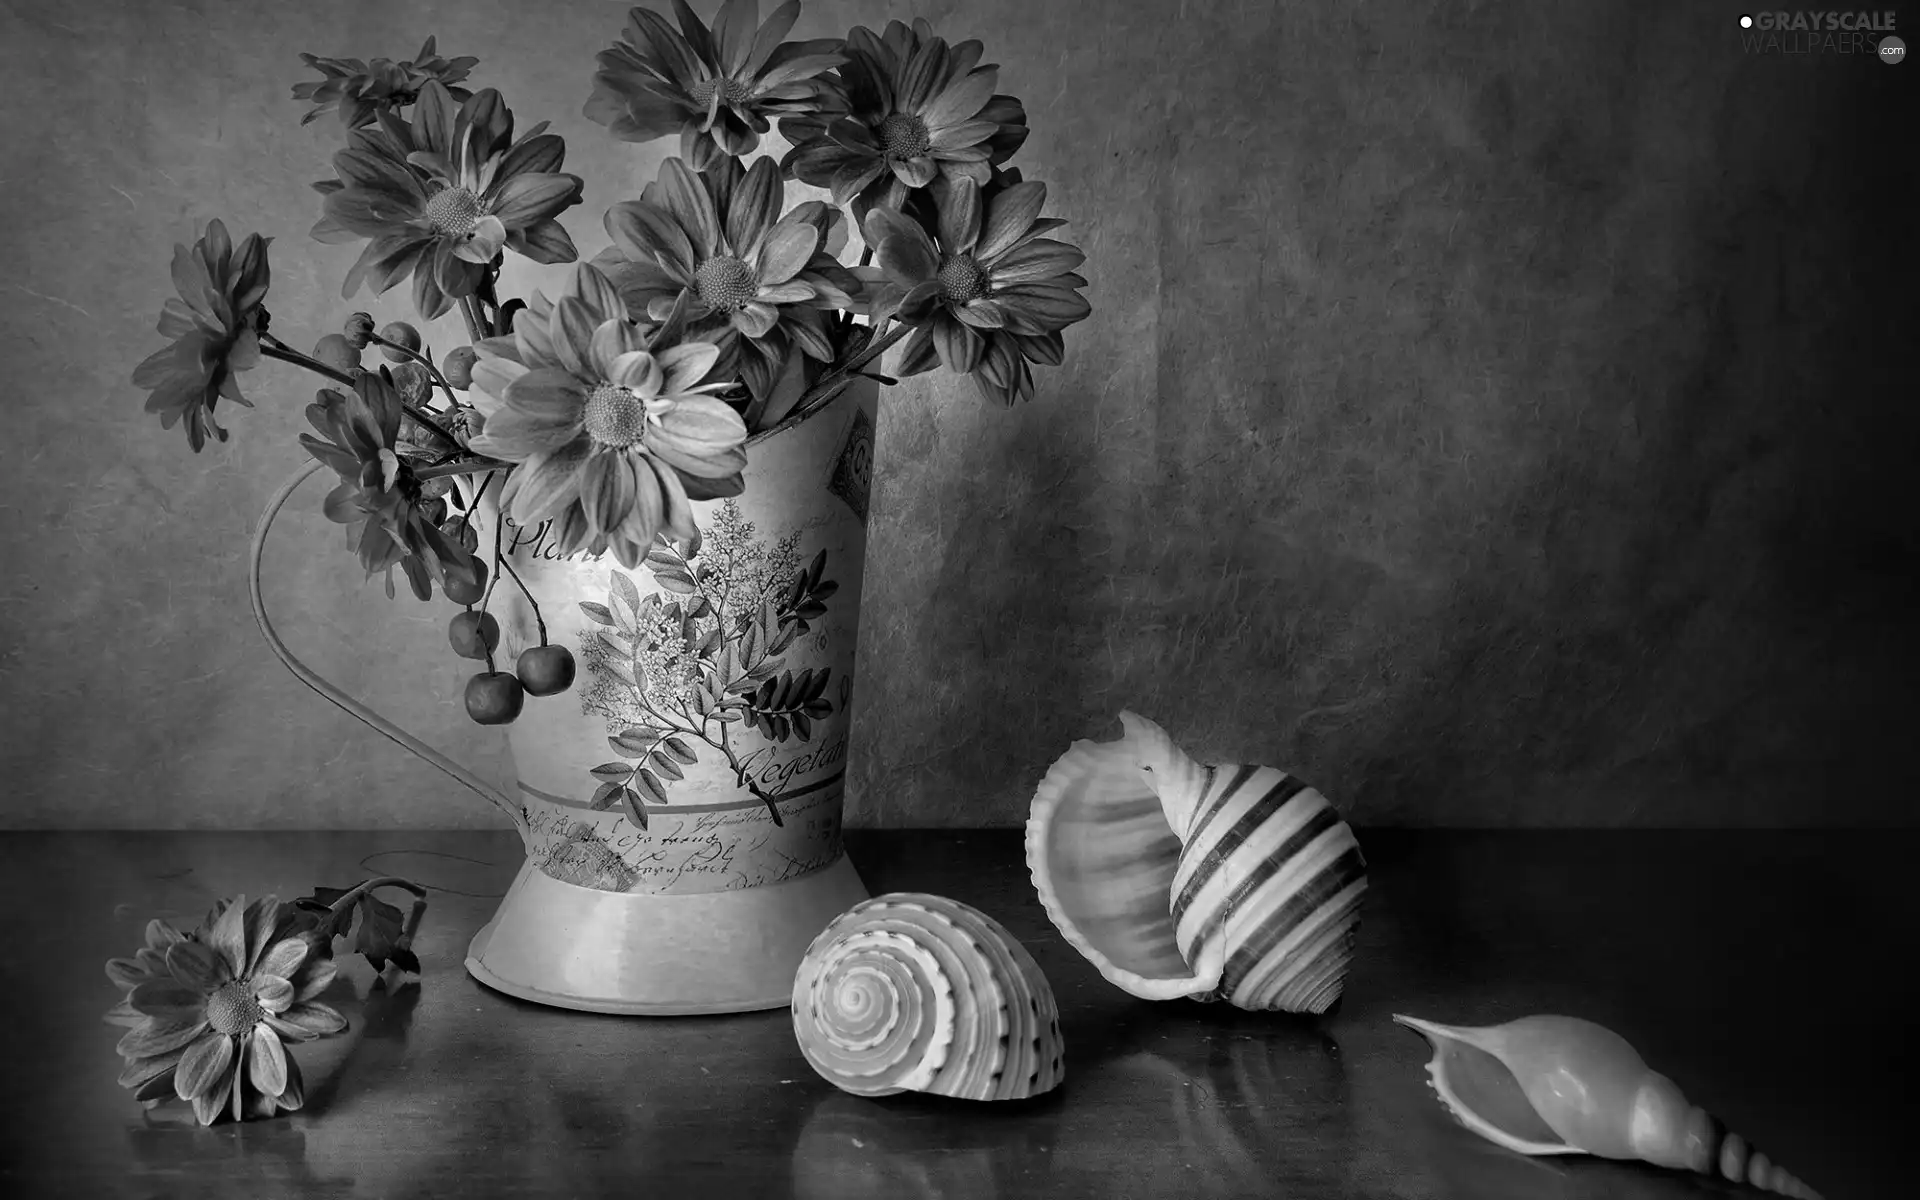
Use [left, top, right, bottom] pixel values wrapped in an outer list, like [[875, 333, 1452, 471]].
[[866, 177, 1092, 405]]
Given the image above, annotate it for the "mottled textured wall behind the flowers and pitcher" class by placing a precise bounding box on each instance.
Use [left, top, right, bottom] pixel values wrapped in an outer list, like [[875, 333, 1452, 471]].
[[0, 0, 1920, 828]]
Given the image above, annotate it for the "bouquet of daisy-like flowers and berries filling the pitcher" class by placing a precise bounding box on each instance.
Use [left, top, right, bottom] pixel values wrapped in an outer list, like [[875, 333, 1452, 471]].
[[132, 0, 1091, 724]]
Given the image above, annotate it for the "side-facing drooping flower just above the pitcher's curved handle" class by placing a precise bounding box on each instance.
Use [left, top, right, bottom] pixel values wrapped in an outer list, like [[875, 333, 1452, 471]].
[[300, 371, 476, 601]]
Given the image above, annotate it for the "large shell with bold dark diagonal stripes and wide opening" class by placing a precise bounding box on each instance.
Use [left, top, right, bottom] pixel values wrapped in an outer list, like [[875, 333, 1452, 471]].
[[1027, 712, 1367, 1012]]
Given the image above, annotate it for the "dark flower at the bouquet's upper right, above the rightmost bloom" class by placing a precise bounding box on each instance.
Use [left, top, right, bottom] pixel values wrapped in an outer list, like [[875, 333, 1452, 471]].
[[780, 19, 1027, 221]]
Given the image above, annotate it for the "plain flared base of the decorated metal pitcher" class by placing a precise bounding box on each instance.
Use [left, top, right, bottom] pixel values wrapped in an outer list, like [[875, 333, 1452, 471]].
[[467, 854, 868, 1016]]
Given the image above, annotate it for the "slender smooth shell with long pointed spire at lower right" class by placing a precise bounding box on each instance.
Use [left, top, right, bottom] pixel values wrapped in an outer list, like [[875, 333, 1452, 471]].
[[1394, 1014, 1820, 1200]]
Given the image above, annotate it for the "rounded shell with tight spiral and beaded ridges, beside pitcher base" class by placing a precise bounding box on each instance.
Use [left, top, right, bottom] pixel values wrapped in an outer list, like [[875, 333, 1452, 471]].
[[793, 893, 1066, 1100]]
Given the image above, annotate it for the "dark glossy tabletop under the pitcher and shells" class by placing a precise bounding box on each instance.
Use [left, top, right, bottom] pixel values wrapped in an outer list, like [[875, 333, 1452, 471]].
[[0, 831, 1920, 1200]]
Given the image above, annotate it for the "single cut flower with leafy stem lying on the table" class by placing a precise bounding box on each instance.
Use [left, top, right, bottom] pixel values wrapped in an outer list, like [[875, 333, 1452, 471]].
[[106, 877, 426, 1125]]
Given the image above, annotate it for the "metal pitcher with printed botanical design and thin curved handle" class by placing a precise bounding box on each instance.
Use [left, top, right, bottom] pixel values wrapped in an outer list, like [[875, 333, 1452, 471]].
[[250, 378, 877, 1014]]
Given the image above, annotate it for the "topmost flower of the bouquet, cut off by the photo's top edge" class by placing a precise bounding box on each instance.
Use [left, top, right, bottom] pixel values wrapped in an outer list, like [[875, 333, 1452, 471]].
[[584, 0, 845, 171]]
